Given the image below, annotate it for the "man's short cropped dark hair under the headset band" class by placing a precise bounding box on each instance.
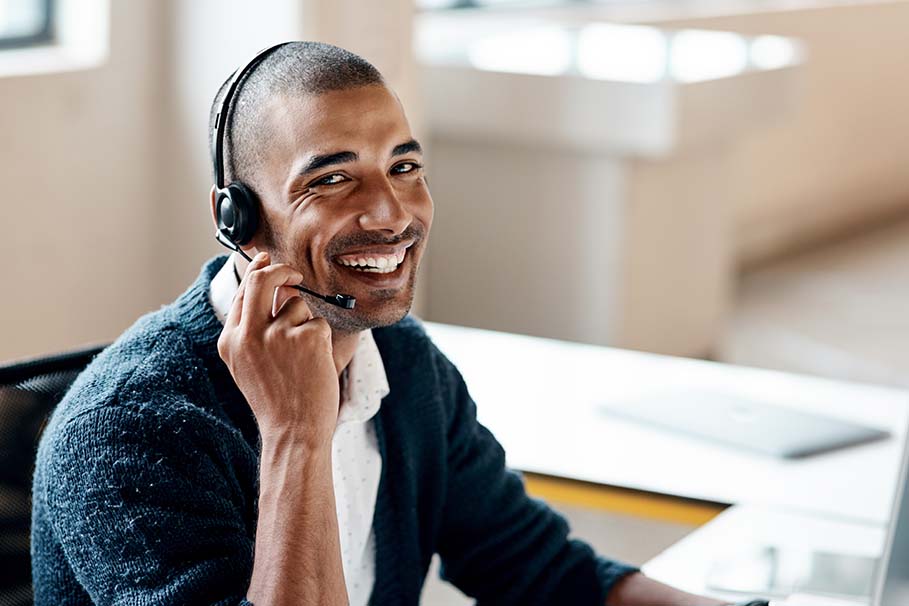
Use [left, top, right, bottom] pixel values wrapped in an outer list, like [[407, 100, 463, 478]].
[[208, 42, 385, 189]]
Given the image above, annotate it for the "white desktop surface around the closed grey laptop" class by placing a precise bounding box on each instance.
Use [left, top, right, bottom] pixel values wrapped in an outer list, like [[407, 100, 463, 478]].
[[426, 323, 909, 526]]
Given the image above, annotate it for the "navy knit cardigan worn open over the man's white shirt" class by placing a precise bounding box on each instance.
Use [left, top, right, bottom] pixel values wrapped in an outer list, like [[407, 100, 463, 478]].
[[32, 256, 635, 606]]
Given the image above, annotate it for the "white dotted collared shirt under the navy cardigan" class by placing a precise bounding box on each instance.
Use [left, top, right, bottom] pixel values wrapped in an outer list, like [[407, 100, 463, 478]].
[[209, 259, 389, 606]]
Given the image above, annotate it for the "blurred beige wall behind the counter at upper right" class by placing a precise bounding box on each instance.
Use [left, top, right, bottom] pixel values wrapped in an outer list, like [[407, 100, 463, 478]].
[[539, 0, 909, 266]]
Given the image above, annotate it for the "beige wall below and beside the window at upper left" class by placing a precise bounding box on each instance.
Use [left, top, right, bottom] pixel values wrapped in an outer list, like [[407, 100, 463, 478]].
[[0, 0, 161, 360]]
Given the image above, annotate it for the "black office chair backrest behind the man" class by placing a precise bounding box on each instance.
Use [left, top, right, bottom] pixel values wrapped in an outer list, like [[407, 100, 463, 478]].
[[0, 346, 104, 606]]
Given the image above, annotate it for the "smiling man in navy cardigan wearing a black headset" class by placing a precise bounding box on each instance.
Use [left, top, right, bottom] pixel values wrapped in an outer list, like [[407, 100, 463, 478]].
[[32, 43, 752, 606]]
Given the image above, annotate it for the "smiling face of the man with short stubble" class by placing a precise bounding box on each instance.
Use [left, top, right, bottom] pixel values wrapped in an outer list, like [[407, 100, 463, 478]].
[[252, 86, 433, 332]]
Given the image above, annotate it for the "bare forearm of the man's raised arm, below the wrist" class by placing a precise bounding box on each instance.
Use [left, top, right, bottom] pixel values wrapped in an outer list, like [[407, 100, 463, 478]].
[[247, 436, 348, 606]]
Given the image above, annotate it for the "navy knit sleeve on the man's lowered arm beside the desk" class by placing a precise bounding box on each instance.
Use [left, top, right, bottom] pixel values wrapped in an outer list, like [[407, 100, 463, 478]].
[[436, 352, 637, 606]]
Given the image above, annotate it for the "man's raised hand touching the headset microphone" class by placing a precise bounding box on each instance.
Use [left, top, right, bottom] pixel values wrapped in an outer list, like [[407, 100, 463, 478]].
[[218, 253, 340, 448]]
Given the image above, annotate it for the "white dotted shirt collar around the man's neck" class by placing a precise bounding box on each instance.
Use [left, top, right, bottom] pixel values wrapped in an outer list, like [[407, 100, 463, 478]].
[[209, 257, 390, 425]]
